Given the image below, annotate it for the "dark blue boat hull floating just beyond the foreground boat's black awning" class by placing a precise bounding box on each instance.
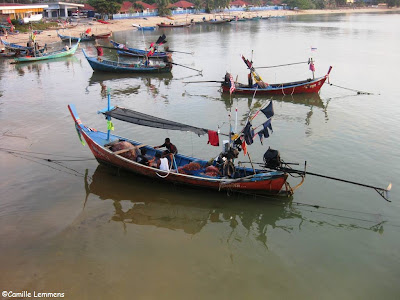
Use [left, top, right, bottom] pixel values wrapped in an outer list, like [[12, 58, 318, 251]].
[[82, 49, 172, 73]]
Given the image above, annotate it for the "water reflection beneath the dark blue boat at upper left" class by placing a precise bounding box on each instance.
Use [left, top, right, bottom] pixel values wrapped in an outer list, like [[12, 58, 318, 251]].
[[86, 72, 173, 98]]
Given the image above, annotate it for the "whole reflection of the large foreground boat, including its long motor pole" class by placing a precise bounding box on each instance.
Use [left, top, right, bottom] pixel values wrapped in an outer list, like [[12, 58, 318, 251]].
[[84, 165, 385, 246]]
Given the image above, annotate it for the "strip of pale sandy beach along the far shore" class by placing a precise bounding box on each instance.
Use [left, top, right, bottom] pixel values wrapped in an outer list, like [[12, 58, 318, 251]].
[[2, 8, 400, 45]]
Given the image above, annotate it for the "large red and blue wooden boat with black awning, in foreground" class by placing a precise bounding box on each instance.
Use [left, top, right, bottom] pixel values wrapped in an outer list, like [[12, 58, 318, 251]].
[[68, 104, 288, 194]]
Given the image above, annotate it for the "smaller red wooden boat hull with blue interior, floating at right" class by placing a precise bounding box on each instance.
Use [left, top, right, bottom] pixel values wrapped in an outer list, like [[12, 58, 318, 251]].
[[221, 67, 332, 95]]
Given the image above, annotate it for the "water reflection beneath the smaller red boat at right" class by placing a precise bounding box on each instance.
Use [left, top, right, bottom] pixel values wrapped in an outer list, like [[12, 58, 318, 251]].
[[221, 93, 329, 125]]
